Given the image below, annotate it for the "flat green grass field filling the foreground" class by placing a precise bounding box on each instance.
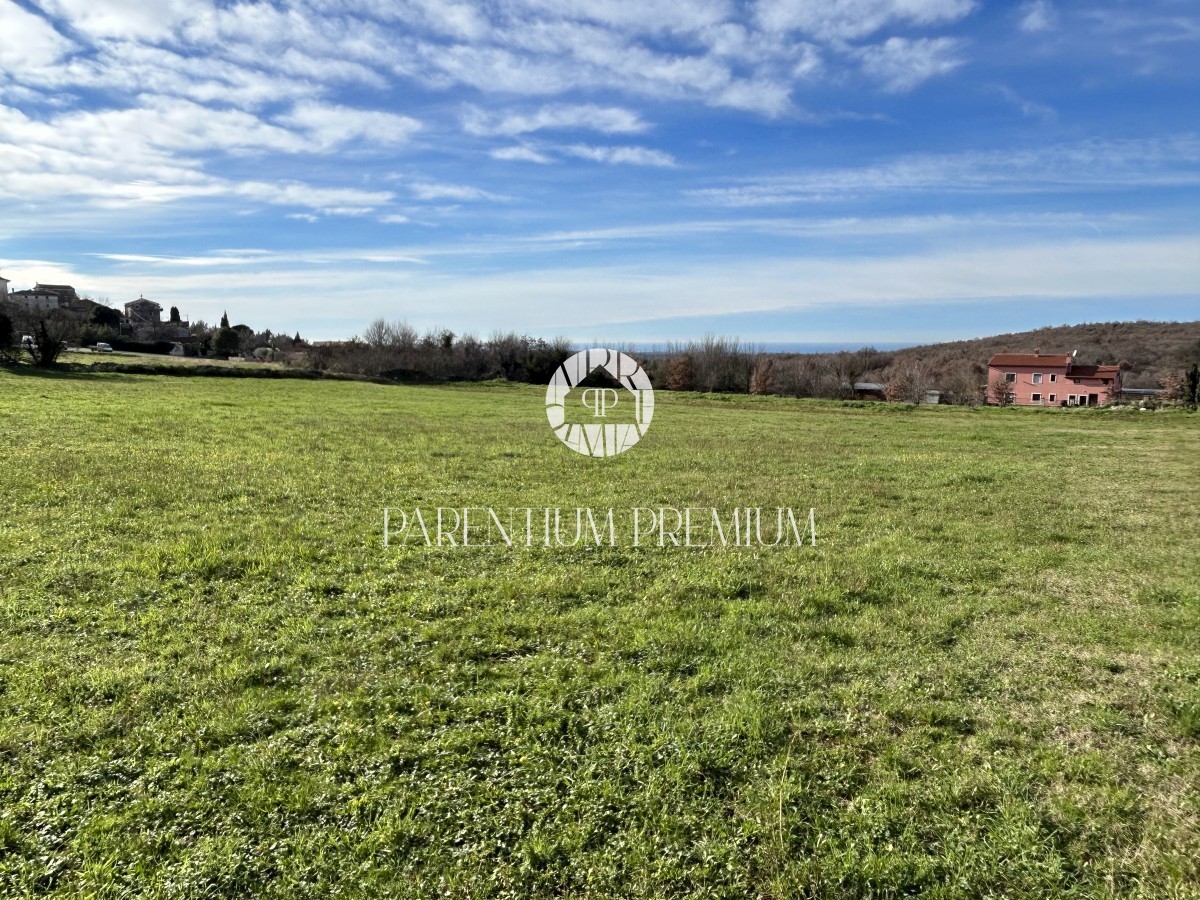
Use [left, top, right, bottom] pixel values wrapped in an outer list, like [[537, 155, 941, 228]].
[[0, 370, 1200, 898]]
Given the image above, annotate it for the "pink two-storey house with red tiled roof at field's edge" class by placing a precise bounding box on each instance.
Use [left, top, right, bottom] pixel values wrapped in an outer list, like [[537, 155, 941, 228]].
[[988, 350, 1121, 407]]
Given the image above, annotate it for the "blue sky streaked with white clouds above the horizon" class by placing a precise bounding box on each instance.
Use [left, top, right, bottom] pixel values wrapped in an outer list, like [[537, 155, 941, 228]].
[[0, 0, 1200, 346]]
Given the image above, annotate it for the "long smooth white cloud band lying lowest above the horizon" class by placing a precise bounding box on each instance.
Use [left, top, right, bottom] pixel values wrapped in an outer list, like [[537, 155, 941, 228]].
[[56, 234, 1200, 338]]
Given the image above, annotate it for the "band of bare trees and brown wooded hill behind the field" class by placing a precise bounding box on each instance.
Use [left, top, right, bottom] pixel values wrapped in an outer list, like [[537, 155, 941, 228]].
[[0, 306, 1200, 404]]
